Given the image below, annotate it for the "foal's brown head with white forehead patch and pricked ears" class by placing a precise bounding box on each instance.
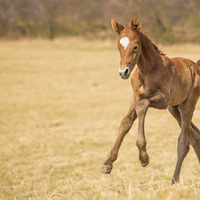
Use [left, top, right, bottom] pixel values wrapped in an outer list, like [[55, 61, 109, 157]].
[[111, 16, 141, 79]]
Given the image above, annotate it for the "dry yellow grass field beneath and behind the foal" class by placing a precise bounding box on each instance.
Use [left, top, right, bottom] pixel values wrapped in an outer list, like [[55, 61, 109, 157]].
[[0, 38, 200, 200]]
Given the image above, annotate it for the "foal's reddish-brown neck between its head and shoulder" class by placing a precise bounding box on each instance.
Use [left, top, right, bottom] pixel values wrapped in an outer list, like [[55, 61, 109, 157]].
[[137, 32, 160, 77]]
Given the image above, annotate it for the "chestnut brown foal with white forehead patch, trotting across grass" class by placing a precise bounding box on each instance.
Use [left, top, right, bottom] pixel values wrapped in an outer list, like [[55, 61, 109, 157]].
[[102, 16, 200, 184]]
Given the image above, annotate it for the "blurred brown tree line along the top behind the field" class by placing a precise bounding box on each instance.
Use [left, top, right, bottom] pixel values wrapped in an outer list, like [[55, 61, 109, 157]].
[[0, 0, 200, 43]]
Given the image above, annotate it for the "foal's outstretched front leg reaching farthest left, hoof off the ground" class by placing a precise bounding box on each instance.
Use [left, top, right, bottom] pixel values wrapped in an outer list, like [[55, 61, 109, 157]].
[[101, 96, 137, 174]]
